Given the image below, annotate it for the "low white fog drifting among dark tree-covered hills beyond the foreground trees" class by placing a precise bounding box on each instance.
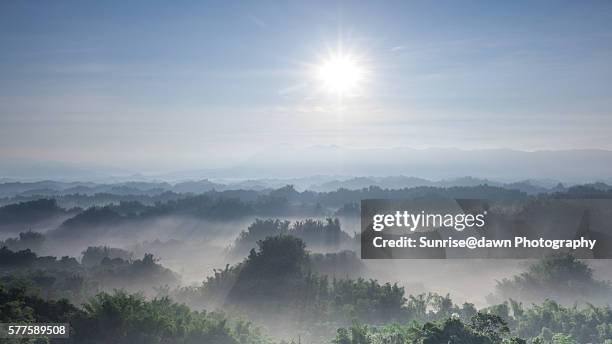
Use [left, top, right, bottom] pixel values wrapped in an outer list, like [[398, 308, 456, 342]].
[[0, 180, 612, 341]]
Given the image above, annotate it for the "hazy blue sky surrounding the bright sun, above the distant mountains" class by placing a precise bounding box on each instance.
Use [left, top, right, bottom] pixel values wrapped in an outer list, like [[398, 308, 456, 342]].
[[0, 1, 612, 170]]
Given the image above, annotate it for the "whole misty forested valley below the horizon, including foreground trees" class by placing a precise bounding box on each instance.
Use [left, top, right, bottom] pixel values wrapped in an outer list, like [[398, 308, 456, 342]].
[[0, 181, 612, 344]]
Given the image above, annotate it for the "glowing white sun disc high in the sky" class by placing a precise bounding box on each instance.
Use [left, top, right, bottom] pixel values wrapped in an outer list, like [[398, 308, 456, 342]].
[[315, 54, 365, 96]]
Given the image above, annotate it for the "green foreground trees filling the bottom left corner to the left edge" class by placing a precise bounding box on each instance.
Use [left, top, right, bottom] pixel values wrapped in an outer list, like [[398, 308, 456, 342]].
[[0, 286, 269, 344]]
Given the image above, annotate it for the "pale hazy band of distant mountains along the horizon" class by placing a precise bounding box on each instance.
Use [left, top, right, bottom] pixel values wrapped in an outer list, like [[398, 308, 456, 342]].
[[0, 146, 612, 185]]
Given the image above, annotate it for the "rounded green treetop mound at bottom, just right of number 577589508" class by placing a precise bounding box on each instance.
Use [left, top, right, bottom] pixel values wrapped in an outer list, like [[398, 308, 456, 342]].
[[71, 292, 268, 344]]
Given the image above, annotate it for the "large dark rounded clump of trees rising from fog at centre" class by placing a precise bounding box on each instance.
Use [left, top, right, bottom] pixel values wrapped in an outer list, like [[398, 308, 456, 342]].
[[177, 235, 408, 340]]
